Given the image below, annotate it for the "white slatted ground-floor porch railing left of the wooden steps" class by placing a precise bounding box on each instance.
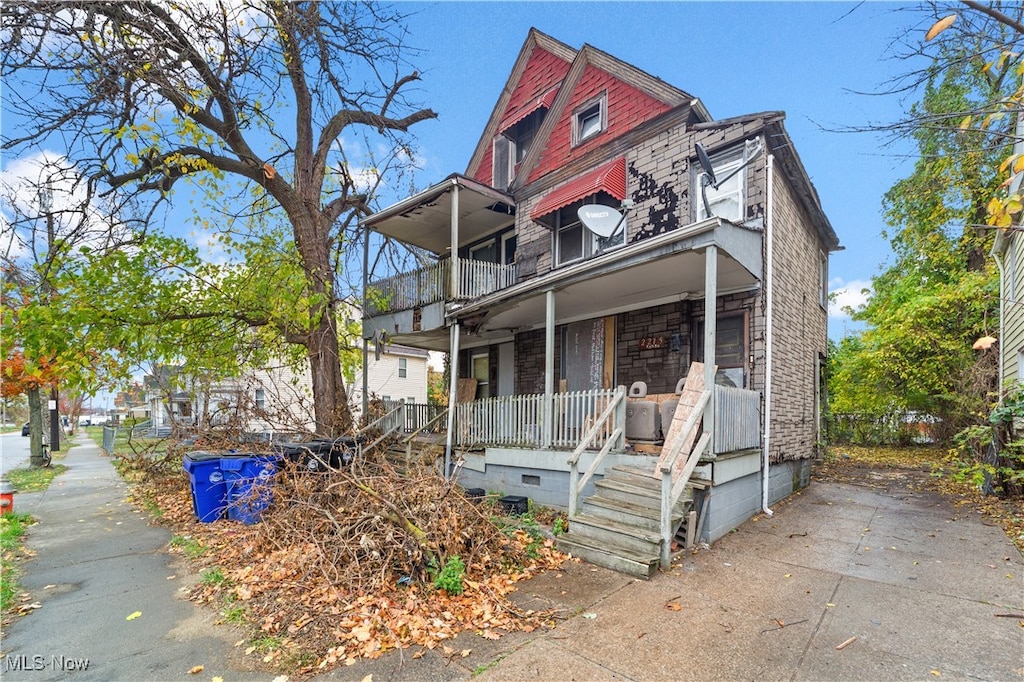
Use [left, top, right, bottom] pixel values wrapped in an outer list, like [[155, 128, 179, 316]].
[[454, 388, 626, 447]]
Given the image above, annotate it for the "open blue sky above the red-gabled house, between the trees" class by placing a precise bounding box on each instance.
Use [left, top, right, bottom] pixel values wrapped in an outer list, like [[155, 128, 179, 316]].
[[398, 2, 928, 338]]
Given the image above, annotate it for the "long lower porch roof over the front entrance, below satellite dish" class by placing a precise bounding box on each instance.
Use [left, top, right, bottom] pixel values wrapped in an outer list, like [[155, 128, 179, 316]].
[[448, 218, 762, 347]]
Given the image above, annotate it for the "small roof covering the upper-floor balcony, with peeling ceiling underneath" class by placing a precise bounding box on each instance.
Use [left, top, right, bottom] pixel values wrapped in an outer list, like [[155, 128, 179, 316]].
[[362, 173, 515, 255]]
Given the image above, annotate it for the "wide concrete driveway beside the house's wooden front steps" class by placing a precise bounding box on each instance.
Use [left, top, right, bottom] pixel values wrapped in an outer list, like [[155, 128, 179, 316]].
[[328, 462, 1024, 680]]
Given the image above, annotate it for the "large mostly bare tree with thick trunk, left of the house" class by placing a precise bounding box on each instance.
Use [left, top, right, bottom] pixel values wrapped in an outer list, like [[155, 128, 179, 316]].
[[0, 0, 436, 433]]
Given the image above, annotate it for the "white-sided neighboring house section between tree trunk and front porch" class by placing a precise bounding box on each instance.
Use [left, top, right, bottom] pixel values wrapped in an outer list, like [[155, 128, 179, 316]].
[[349, 344, 428, 418]]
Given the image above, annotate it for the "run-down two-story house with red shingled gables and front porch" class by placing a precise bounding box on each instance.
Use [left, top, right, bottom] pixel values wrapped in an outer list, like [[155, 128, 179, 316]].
[[362, 30, 840, 574]]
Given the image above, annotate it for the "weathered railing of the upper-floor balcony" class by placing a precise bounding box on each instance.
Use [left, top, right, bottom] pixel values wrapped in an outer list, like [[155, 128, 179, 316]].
[[367, 258, 517, 315]]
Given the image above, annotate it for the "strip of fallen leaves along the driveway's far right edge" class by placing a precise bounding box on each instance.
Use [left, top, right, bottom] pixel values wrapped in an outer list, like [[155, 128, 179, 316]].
[[812, 445, 1024, 552]]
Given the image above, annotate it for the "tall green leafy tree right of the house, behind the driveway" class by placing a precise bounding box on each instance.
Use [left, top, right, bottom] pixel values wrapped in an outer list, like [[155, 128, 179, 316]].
[[830, 3, 1020, 437]]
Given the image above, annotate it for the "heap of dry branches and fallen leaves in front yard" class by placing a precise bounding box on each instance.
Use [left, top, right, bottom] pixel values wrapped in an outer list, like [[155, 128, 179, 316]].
[[134, 444, 566, 673]]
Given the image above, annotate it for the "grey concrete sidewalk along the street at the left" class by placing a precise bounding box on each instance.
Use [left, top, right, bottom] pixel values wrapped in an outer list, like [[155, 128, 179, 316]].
[[0, 434, 264, 682]]
